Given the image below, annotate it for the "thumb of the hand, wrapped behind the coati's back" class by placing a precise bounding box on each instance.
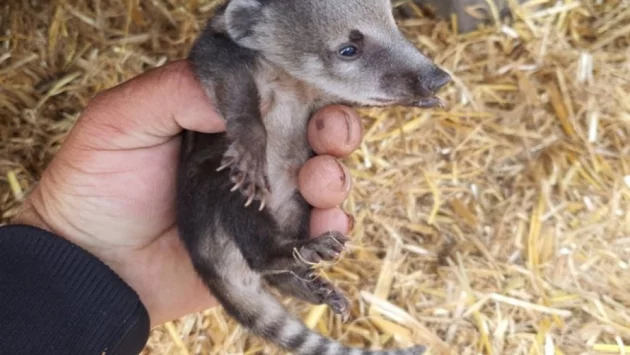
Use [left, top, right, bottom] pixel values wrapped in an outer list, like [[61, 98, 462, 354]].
[[76, 60, 225, 150]]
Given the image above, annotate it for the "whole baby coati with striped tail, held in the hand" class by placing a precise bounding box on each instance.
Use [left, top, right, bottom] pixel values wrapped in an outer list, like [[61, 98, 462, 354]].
[[177, 0, 450, 355]]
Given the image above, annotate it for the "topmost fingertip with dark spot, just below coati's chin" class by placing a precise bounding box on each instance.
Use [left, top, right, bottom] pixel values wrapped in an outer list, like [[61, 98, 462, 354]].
[[308, 105, 363, 158]]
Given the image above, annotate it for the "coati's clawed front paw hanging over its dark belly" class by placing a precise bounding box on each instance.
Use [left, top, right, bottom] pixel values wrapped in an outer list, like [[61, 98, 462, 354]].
[[217, 141, 271, 211]]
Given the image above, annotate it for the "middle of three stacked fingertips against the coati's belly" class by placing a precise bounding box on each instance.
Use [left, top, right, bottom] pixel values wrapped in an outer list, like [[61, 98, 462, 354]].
[[298, 155, 352, 208]]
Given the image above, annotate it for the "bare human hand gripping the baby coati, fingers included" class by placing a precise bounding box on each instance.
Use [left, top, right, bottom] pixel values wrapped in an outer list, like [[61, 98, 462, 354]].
[[14, 61, 361, 326]]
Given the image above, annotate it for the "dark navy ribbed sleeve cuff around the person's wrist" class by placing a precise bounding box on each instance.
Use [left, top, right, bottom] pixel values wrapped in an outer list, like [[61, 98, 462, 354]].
[[0, 225, 149, 355]]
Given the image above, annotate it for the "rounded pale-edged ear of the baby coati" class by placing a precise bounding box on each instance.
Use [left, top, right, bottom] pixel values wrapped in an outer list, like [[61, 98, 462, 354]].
[[223, 0, 267, 49]]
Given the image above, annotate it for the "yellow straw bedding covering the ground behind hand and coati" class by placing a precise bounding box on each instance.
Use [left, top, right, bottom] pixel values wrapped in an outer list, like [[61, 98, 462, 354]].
[[0, 0, 630, 355]]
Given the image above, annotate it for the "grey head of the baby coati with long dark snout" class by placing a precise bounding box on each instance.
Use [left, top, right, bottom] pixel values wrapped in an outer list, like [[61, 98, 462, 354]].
[[220, 0, 451, 107]]
